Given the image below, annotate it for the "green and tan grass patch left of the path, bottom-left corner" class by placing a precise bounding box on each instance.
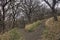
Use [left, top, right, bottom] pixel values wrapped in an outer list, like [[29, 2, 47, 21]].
[[0, 28, 24, 40]]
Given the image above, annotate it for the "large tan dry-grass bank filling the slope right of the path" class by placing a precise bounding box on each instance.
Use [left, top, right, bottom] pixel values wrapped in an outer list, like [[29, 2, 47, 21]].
[[42, 16, 60, 40]]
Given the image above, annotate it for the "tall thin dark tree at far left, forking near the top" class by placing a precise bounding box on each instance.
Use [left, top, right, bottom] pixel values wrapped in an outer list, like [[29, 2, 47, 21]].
[[0, 0, 11, 32]]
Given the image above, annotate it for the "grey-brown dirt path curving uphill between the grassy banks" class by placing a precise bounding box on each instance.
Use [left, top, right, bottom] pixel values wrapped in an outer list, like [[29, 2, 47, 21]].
[[20, 20, 45, 40]]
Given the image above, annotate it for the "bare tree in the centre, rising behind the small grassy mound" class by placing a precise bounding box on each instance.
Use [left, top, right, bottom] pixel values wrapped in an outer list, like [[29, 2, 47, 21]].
[[19, 0, 42, 22]]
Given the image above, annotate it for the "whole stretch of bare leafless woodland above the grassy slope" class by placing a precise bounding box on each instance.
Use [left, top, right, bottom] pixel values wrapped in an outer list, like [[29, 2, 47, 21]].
[[0, 0, 60, 33]]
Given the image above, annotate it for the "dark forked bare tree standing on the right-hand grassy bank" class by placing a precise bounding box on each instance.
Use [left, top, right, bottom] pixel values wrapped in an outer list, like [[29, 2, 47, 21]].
[[44, 0, 58, 21]]
